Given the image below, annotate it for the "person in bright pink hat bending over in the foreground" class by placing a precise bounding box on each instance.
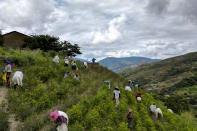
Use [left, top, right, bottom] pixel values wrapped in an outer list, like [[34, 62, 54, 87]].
[[50, 110, 68, 131]]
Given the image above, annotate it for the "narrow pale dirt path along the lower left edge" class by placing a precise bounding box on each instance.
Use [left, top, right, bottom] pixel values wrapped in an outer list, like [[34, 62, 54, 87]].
[[0, 87, 19, 131]]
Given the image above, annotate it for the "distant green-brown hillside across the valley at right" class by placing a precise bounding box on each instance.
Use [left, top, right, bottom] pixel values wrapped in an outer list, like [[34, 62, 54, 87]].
[[120, 52, 197, 117]]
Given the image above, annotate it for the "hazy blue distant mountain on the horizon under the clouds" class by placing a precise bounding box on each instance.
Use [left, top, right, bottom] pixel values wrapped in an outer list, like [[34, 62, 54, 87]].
[[99, 56, 160, 72]]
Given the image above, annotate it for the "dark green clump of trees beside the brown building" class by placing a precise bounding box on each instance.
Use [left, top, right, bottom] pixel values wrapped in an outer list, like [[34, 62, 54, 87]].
[[23, 35, 81, 56]]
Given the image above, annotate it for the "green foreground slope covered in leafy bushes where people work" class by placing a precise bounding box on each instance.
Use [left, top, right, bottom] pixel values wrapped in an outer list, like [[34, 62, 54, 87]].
[[0, 48, 197, 131]]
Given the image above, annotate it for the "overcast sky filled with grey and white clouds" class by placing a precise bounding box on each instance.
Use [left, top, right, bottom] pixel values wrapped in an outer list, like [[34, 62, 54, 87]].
[[0, 0, 197, 59]]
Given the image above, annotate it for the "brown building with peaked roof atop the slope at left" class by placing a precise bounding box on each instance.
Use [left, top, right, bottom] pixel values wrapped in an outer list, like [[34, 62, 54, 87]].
[[3, 31, 29, 49]]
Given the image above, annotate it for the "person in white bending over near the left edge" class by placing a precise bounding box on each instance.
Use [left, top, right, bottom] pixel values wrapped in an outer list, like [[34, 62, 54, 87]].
[[12, 71, 23, 88]]
